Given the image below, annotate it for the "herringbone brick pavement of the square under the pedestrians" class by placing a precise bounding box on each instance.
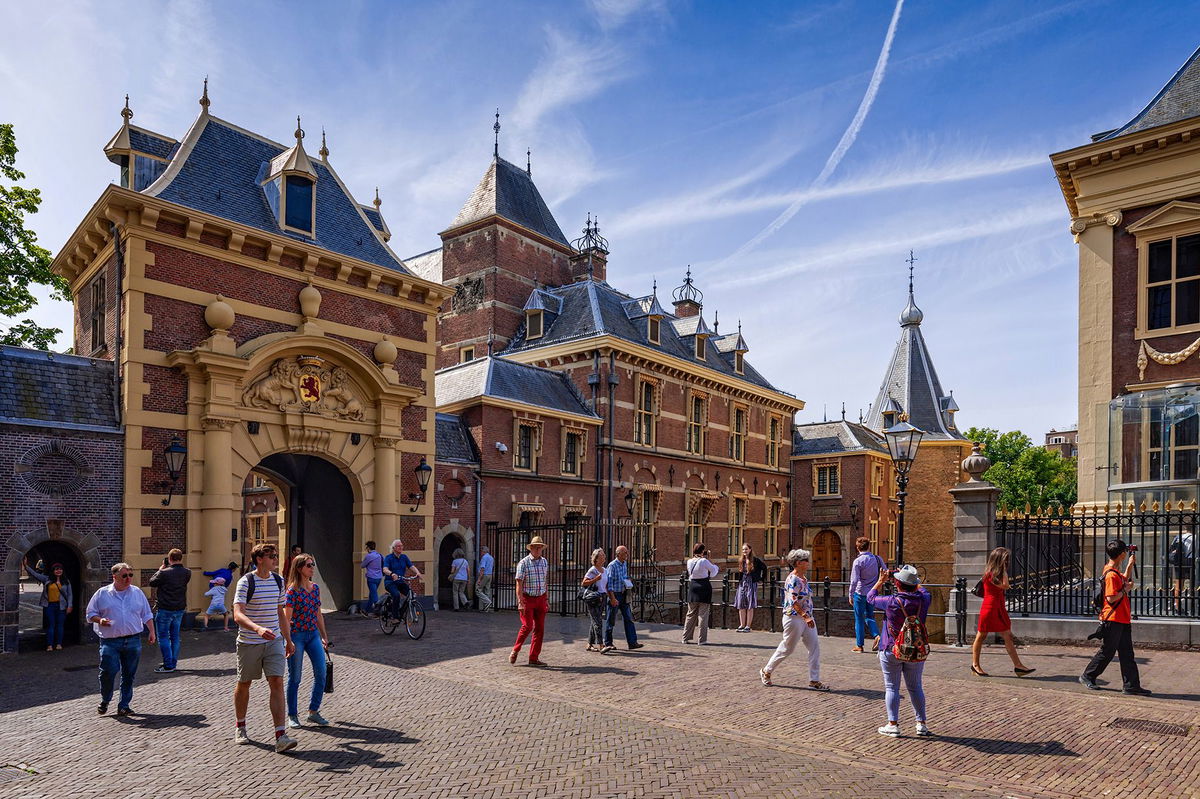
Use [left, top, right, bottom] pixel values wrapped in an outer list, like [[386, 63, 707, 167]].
[[0, 612, 1200, 799]]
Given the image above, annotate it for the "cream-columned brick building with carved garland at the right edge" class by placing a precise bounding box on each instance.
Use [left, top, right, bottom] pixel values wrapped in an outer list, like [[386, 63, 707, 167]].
[[1050, 44, 1200, 506]]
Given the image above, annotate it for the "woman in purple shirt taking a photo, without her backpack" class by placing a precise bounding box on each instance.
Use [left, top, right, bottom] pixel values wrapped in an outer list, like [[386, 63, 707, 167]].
[[866, 565, 932, 738]]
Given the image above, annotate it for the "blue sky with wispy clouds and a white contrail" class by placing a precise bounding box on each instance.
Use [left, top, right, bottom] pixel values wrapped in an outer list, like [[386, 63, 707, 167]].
[[0, 0, 1200, 440]]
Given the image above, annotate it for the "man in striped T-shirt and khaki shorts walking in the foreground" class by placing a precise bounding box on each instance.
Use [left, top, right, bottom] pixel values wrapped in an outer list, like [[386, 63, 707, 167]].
[[233, 543, 296, 752]]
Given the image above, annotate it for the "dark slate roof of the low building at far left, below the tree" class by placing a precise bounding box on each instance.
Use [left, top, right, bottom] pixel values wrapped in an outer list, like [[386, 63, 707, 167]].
[[0, 346, 120, 429]]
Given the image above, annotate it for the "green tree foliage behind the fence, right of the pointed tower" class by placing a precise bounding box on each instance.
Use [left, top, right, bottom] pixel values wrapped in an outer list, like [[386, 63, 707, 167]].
[[965, 427, 1078, 509]]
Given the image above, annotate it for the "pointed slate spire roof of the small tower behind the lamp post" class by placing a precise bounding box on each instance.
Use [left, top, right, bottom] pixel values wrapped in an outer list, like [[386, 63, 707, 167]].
[[864, 288, 966, 440]]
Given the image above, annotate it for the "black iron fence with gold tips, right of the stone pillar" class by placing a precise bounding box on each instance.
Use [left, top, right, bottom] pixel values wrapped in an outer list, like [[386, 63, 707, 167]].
[[996, 503, 1200, 619]]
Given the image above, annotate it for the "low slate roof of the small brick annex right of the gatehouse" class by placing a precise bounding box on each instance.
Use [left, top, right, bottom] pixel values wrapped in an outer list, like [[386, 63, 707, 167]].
[[433, 355, 600, 419]]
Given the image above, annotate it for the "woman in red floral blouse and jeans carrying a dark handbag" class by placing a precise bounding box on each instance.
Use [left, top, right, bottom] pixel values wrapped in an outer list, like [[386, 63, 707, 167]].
[[283, 552, 330, 728]]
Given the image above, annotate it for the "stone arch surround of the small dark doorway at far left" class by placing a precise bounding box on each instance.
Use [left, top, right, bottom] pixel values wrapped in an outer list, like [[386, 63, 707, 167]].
[[0, 519, 112, 651]]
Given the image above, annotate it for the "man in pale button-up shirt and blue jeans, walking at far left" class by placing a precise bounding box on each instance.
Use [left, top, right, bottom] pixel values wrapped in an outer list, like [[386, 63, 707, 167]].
[[85, 563, 156, 716]]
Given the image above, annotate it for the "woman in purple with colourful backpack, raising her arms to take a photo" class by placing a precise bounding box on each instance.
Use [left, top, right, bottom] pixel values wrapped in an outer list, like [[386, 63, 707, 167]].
[[866, 565, 934, 738]]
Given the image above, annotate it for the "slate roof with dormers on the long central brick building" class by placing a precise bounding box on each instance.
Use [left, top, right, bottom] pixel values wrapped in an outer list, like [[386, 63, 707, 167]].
[[499, 280, 791, 393]]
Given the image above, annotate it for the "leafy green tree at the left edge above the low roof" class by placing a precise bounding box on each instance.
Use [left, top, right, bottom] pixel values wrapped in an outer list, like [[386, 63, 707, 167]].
[[0, 124, 71, 349]]
